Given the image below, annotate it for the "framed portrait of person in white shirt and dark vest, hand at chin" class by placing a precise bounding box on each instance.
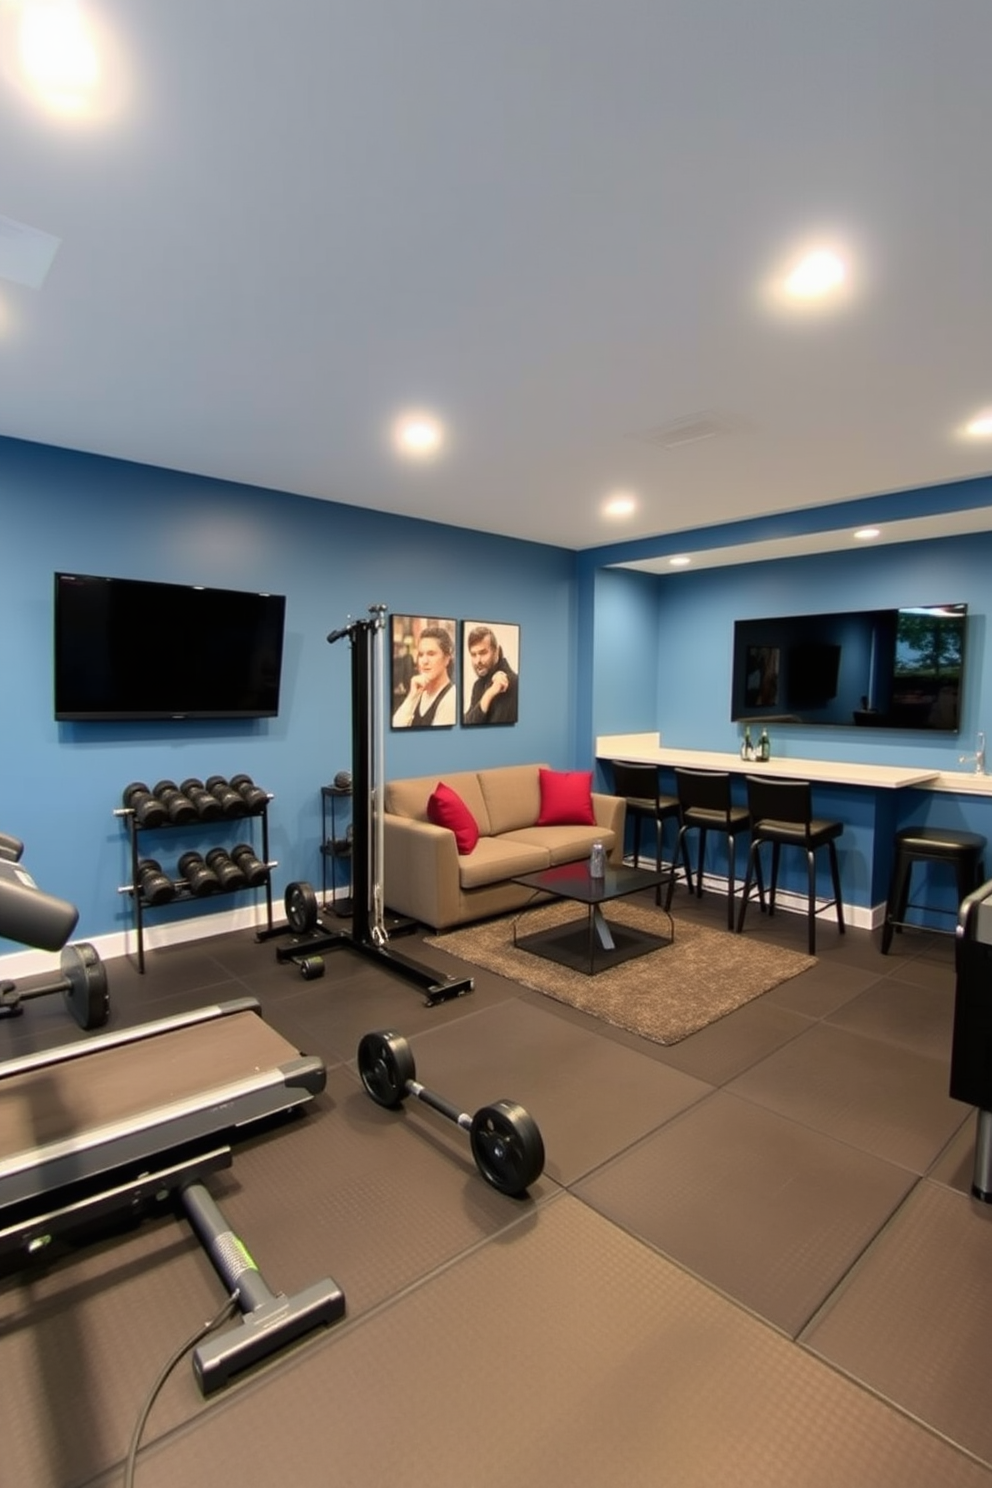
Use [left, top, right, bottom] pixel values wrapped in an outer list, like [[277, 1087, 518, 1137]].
[[390, 615, 458, 729]]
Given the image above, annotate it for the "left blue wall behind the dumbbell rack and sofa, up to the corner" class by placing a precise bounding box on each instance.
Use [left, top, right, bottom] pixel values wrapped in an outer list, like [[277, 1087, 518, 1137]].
[[0, 439, 574, 949]]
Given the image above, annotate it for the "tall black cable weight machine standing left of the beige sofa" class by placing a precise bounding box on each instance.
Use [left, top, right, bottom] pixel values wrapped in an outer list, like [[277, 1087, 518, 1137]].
[[275, 604, 474, 1007]]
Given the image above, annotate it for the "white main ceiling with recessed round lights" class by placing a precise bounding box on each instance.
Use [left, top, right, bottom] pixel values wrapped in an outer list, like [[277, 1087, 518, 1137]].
[[0, 0, 992, 549]]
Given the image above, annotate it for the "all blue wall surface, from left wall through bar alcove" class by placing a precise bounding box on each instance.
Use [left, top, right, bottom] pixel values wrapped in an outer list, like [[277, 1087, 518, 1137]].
[[0, 439, 992, 949]]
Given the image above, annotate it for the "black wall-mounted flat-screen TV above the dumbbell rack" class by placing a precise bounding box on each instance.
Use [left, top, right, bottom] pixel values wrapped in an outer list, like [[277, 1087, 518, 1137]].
[[55, 573, 286, 722]]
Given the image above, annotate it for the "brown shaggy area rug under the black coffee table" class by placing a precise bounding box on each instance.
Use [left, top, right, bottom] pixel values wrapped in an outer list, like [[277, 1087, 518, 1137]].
[[425, 899, 817, 1045]]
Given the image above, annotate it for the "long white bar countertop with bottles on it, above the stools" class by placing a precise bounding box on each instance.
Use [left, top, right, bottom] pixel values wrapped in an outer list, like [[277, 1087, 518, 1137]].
[[596, 734, 992, 796]]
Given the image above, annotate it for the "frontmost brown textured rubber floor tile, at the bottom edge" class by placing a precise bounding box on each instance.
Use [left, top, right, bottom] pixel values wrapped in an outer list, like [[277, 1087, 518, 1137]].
[[110, 1195, 992, 1488]]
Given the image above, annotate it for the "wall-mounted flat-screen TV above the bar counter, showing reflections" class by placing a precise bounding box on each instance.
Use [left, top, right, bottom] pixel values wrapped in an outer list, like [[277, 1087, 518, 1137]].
[[730, 604, 968, 734]]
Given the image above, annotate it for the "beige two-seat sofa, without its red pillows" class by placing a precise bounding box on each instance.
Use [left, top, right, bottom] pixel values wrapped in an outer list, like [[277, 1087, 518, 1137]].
[[382, 765, 626, 930]]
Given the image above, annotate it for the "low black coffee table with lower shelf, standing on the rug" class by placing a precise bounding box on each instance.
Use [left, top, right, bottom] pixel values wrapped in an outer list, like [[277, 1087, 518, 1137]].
[[513, 862, 675, 976]]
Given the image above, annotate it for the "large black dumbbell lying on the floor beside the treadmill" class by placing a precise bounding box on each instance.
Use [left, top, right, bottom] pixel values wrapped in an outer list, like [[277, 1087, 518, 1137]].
[[358, 1030, 544, 1195]]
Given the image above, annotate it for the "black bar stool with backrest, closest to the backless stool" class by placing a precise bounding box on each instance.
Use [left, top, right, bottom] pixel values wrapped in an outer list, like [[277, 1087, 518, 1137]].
[[738, 775, 845, 955]]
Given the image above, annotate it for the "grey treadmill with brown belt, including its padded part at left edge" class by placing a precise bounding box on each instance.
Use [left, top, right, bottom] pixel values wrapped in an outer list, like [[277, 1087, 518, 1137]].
[[0, 833, 345, 1394]]
